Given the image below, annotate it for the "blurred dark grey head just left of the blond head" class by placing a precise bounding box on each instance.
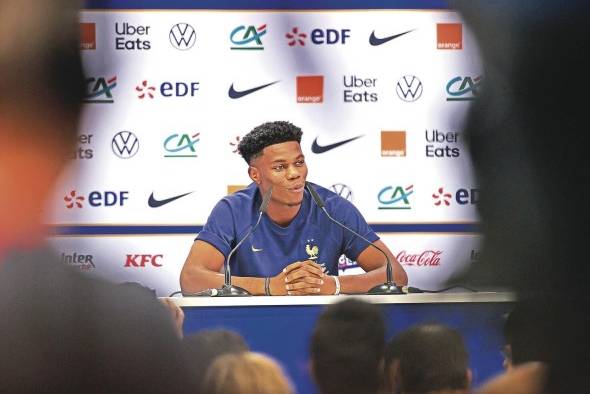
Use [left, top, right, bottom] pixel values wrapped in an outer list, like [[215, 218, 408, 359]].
[[182, 329, 249, 393]]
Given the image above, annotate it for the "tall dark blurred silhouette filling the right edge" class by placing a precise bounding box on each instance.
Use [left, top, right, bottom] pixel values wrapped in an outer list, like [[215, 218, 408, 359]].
[[453, 0, 590, 393]]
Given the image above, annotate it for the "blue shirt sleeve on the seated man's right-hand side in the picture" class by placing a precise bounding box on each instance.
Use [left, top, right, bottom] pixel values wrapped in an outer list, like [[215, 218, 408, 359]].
[[335, 197, 379, 260]]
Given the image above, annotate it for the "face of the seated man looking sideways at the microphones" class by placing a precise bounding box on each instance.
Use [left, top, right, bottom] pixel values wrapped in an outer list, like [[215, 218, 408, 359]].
[[248, 141, 307, 206]]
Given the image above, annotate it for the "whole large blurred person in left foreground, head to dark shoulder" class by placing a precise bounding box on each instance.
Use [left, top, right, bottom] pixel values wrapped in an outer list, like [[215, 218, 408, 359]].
[[0, 0, 189, 393]]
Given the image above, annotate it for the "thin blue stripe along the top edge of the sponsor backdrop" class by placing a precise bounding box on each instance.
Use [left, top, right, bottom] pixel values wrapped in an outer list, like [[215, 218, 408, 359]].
[[85, 0, 449, 10]]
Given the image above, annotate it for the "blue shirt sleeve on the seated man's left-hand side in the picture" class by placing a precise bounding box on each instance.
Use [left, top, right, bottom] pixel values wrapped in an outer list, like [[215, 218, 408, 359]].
[[195, 200, 235, 257]]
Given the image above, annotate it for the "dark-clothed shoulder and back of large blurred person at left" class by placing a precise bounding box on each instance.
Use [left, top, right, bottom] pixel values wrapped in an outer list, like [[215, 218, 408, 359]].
[[0, 251, 191, 394]]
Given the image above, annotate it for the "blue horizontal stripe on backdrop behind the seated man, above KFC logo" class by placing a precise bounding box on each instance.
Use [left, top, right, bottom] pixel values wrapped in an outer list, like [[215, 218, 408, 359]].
[[50, 223, 480, 236]]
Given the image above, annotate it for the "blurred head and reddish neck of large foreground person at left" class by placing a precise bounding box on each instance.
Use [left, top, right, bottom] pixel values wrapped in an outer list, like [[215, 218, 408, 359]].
[[0, 0, 84, 252]]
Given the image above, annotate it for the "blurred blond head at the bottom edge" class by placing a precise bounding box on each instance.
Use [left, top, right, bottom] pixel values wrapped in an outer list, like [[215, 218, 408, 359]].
[[202, 352, 294, 394]]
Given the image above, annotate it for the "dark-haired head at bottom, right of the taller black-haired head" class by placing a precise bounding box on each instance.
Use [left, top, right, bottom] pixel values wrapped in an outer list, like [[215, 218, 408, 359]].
[[383, 323, 471, 394]]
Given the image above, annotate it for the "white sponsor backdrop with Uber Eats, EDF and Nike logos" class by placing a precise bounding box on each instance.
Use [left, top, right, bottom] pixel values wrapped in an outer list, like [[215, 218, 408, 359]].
[[47, 2, 482, 296]]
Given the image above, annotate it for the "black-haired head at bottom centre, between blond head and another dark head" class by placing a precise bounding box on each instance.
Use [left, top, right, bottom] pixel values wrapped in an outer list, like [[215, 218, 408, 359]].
[[310, 299, 385, 394]]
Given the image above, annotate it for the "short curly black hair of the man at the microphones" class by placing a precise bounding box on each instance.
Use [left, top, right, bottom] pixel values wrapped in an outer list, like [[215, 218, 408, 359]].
[[238, 121, 303, 164]]
